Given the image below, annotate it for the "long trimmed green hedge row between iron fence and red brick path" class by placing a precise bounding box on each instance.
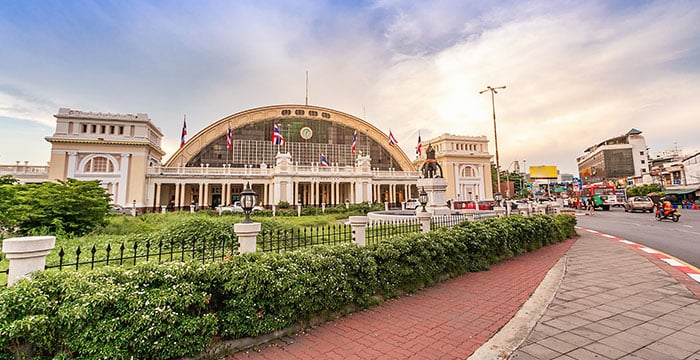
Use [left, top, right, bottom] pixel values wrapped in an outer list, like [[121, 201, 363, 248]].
[[0, 215, 576, 359]]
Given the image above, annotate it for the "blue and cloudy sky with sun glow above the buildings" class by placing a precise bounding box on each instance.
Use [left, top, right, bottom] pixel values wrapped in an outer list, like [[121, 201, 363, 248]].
[[0, 0, 700, 174]]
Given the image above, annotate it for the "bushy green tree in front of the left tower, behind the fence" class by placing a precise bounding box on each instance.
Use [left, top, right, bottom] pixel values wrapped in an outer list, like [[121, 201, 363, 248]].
[[13, 179, 110, 235]]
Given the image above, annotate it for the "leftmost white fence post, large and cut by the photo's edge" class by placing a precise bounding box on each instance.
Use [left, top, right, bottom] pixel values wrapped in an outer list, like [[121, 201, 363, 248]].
[[2, 236, 56, 285]]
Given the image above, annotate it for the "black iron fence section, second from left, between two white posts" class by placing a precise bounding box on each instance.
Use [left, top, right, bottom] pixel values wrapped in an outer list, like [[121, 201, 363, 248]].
[[256, 224, 352, 252]]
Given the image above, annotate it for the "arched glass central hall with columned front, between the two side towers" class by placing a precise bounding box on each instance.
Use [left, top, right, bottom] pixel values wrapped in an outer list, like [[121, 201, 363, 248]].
[[147, 105, 419, 208]]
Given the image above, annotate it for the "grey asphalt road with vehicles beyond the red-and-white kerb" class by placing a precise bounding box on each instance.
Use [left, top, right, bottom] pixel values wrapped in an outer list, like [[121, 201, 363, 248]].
[[576, 208, 700, 268]]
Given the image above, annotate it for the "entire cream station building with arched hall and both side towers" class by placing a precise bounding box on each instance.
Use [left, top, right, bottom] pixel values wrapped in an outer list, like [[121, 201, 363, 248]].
[[0, 105, 491, 211]]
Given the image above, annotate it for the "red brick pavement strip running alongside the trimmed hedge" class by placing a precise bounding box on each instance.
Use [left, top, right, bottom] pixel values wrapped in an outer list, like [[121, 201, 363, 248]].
[[227, 239, 575, 359]]
